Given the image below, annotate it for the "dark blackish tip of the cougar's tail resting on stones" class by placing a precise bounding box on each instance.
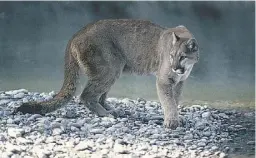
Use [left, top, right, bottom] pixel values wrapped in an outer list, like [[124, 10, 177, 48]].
[[14, 103, 42, 114]]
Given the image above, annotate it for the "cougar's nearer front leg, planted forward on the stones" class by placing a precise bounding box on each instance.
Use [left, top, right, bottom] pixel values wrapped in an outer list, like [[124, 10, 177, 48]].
[[156, 78, 179, 129]]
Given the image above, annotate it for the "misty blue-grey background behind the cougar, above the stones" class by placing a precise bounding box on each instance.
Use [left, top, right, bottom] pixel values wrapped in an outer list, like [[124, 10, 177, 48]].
[[0, 1, 255, 105]]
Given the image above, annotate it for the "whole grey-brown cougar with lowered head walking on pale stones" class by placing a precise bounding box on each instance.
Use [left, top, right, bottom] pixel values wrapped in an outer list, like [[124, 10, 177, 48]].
[[16, 19, 199, 129]]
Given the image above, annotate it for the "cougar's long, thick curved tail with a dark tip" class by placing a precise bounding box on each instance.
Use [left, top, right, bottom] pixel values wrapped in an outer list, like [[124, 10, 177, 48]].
[[16, 41, 79, 114]]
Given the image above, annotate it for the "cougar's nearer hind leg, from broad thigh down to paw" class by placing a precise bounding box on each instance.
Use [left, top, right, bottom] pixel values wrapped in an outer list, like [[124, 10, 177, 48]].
[[79, 41, 125, 116]]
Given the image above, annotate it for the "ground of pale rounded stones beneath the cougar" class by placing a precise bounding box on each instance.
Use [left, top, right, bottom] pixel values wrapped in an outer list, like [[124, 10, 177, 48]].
[[0, 89, 255, 158]]
